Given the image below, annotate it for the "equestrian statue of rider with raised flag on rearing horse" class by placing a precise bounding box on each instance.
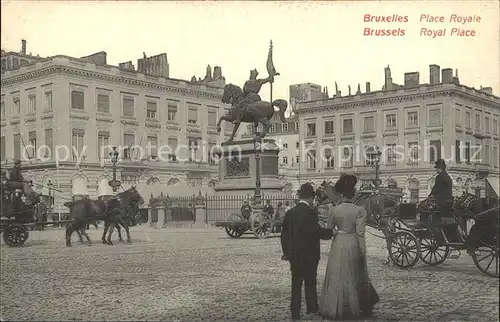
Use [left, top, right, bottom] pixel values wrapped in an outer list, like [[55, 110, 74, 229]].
[[217, 42, 288, 142]]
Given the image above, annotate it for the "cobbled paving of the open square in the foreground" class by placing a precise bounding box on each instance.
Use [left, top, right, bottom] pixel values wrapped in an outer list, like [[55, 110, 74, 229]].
[[0, 227, 498, 322]]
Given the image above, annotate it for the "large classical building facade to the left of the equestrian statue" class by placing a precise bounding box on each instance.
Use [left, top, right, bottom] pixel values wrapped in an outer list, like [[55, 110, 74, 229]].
[[1, 44, 232, 205]]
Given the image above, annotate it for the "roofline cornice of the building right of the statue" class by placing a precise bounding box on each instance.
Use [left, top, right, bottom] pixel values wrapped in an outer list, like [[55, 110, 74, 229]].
[[297, 85, 500, 115]]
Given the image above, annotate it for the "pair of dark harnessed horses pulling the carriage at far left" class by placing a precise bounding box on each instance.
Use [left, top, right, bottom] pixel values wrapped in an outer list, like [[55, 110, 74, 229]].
[[66, 187, 144, 246]]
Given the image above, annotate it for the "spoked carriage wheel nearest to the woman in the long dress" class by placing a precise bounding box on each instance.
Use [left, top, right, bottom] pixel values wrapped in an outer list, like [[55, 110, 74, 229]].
[[389, 231, 420, 268]]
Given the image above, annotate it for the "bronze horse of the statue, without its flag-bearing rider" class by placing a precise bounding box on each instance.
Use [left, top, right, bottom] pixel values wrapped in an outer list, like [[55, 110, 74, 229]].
[[217, 84, 288, 142]]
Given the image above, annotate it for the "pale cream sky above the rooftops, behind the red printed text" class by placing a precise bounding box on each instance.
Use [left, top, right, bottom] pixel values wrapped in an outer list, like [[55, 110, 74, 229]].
[[1, 0, 500, 104]]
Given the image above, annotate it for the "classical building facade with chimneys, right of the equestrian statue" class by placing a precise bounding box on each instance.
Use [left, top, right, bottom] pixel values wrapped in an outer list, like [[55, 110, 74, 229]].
[[296, 65, 500, 201]]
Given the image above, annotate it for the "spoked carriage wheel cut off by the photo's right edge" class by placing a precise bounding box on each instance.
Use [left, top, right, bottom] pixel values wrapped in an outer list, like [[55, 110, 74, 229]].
[[472, 234, 499, 278]]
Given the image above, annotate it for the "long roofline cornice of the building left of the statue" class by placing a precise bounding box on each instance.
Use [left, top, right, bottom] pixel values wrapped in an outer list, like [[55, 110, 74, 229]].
[[1, 65, 222, 101]]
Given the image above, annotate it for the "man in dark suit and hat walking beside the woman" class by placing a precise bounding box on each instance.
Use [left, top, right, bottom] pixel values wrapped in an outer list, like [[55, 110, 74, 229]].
[[281, 183, 332, 320]]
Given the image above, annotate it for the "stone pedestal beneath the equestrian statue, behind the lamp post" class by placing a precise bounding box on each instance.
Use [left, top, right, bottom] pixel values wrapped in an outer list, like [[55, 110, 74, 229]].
[[213, 139, 284, 196]]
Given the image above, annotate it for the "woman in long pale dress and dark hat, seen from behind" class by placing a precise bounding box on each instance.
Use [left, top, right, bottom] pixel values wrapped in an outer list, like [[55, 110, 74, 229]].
[[319, 175, 379, 320]]
